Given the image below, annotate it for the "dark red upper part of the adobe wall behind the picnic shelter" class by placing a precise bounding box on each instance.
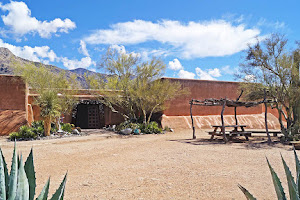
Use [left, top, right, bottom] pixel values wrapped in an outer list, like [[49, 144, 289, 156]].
[[163, 78, 264, 116]]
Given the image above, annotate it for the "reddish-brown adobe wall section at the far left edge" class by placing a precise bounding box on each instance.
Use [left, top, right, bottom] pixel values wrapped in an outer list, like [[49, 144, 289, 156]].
[[0, 75, 27, 135]]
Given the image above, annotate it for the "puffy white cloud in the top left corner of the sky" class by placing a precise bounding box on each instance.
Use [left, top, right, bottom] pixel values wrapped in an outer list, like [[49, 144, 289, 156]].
[[0, 1, 76, 38]]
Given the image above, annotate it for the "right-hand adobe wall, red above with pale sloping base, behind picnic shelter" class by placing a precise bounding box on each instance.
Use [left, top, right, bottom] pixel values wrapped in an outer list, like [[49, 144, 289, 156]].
[[161, 78, 280, 129]]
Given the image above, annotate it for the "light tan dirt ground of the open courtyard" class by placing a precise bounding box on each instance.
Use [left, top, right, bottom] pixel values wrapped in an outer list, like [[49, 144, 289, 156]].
[[0, 130, 300, 200]]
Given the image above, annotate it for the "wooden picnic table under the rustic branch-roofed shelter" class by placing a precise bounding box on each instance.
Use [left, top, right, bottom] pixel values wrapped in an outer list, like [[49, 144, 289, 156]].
[[208, 125, 252, 141]]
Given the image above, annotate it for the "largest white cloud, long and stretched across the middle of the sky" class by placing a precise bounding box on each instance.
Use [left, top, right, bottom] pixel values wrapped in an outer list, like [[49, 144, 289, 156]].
[[84, 20, 260, 58]]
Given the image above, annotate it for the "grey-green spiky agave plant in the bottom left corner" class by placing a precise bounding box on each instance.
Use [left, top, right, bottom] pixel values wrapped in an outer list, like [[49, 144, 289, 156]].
[[0, 143, 67, 200]]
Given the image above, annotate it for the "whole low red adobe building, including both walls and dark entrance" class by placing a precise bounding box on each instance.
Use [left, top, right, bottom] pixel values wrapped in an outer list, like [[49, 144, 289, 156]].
[[0, 75, 280, 135]]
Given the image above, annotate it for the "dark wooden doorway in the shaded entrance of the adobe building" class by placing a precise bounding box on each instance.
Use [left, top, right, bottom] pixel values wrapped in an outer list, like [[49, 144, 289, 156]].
[[75, 103, 105, 129]]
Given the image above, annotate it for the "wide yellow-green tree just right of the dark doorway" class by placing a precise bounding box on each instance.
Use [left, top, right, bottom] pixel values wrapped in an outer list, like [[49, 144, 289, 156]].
[[86, 49, 183, 124]]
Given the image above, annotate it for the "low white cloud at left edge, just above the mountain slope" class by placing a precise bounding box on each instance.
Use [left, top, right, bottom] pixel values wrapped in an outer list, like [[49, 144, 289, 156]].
[[0, 39, 57, 64]]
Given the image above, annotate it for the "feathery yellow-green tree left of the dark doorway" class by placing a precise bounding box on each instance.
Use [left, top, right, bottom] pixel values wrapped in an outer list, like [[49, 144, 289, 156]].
[[13, 64, 78, 136]]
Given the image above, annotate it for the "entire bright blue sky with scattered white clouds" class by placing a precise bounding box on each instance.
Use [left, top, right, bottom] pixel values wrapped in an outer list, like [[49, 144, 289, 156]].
[[0, 0, 300, 81]]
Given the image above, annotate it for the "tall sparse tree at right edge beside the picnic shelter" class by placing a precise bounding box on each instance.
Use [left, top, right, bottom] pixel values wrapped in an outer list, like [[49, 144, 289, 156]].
[[239, 34, 300, 139]]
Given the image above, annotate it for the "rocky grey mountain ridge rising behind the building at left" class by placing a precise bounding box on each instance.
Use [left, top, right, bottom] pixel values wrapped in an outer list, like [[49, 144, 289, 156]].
[[0, 47, 107, 88]]
